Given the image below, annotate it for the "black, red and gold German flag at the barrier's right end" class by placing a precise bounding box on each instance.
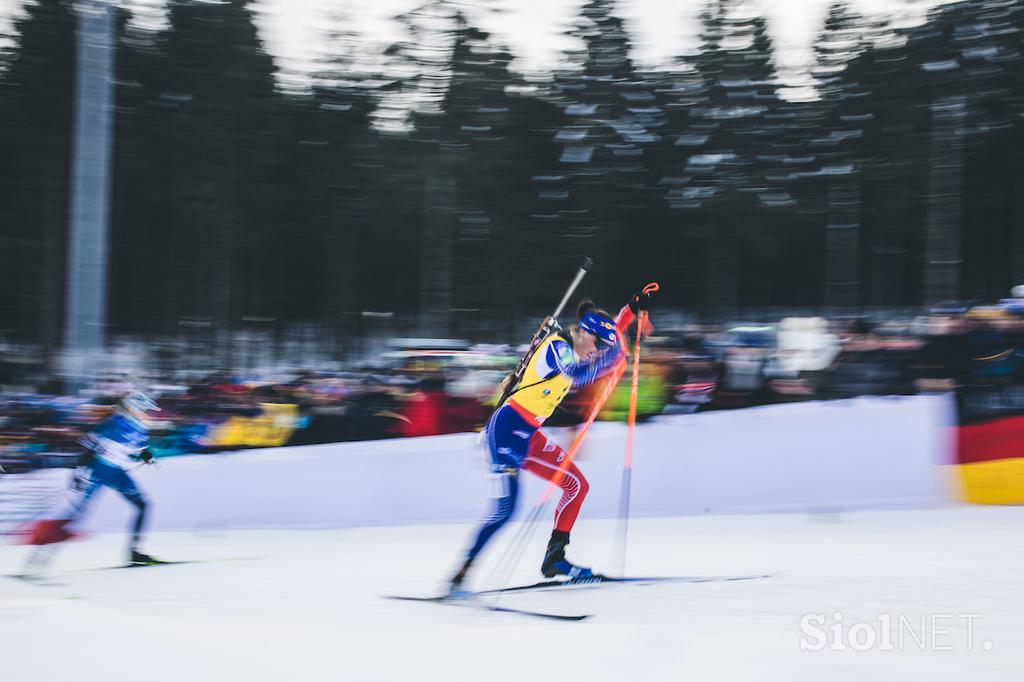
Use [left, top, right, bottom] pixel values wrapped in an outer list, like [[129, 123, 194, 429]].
[[956, 386, 1024, 505]]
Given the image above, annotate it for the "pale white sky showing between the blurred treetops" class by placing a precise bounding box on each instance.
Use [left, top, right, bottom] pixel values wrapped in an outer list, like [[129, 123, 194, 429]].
[[0, 0, 958, 96]]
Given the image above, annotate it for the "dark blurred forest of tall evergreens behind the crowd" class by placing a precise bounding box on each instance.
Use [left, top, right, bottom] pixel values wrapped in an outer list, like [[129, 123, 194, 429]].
[[0, 0, 1024, 358]]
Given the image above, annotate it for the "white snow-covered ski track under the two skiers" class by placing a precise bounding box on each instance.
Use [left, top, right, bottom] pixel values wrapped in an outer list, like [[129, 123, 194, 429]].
[[0, 506, 1024, 682]]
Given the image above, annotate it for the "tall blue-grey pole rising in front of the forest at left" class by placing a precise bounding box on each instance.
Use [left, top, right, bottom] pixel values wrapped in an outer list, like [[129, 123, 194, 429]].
[[63, 0, 117, 391]]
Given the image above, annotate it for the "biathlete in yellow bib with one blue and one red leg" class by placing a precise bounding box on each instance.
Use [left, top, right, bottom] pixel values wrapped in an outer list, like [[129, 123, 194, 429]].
[[450, 284, 650, 595]]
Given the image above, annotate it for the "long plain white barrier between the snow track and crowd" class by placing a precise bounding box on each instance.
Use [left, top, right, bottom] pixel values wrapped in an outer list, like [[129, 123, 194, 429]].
[[37, 395, 953, 530]]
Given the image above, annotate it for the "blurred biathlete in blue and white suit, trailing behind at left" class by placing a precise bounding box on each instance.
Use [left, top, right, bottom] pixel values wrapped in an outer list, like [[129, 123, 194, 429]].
[[24, 391, 161, 578]]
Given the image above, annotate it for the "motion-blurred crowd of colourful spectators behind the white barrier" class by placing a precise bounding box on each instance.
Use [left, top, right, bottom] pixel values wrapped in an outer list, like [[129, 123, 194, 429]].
[[0, 304, 1024, 471]]
